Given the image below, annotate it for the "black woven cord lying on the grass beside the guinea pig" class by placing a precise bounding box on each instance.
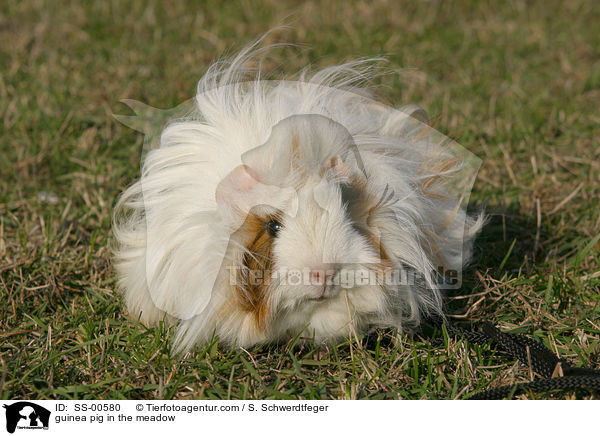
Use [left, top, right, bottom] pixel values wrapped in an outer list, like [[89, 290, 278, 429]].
[[432, 322, 600, 400]]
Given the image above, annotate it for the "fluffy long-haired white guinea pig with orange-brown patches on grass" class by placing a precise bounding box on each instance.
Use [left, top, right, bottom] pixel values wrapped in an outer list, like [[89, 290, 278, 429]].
[[113, 42, 483, 350]]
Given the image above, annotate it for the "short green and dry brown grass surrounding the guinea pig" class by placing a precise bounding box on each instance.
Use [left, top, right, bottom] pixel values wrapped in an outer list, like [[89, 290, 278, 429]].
[[0, 0, 600, 399]]
